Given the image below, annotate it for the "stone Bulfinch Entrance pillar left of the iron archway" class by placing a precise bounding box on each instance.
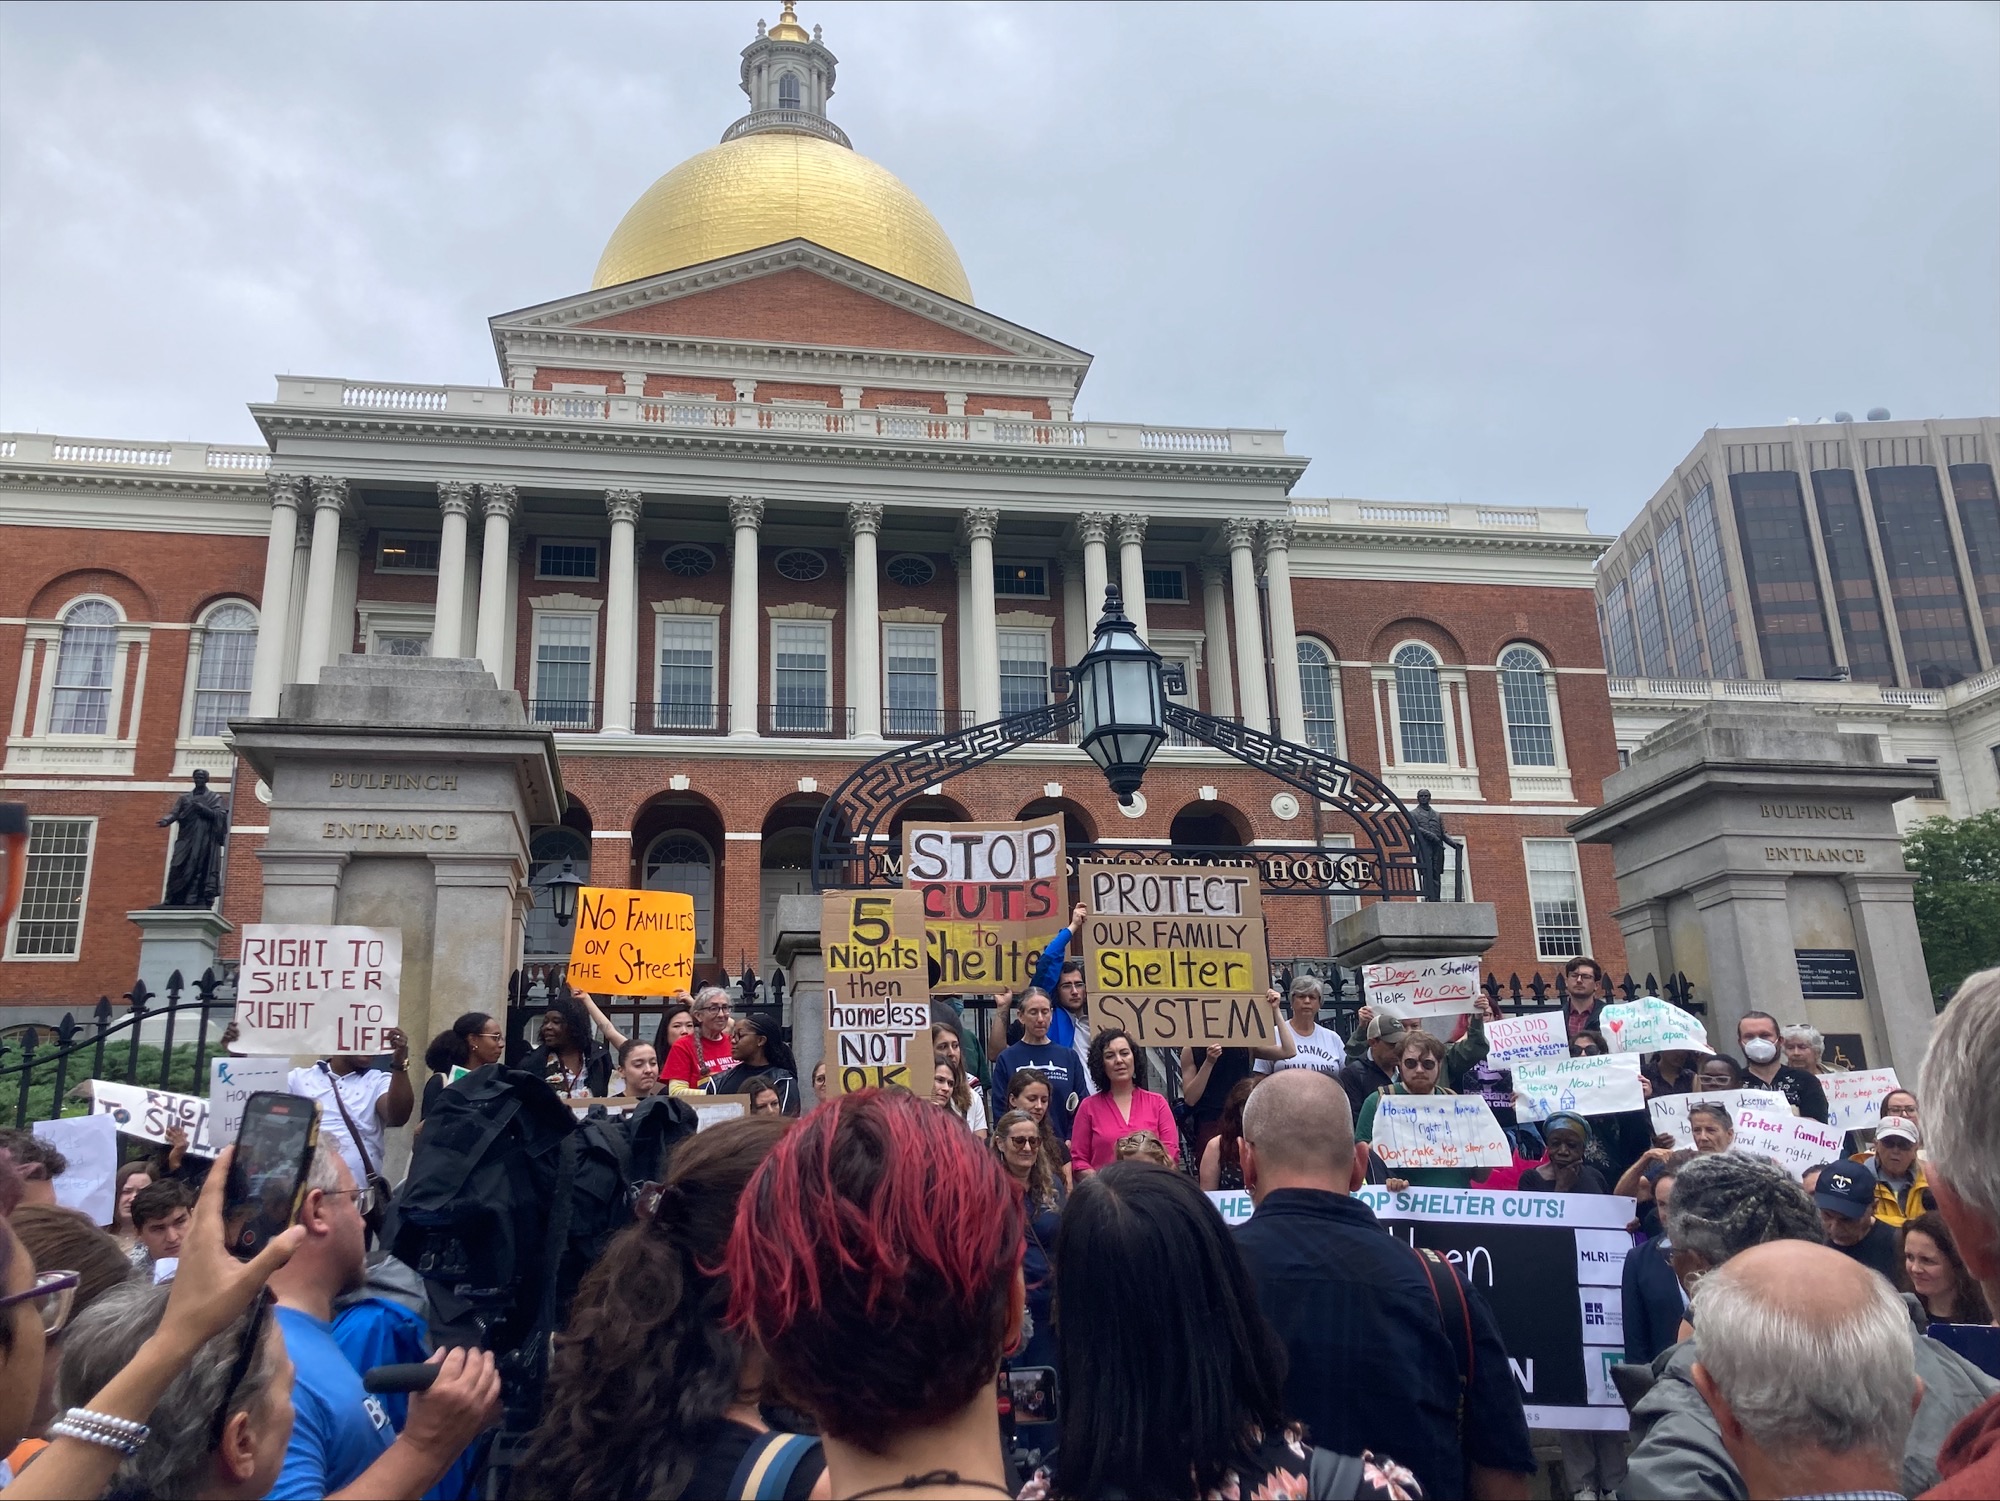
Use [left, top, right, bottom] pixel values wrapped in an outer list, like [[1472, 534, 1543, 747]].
[[232, 656, 562, 1136]]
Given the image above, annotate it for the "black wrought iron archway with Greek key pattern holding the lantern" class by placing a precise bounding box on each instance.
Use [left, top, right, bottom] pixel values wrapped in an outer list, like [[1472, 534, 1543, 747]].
[[812, 694, 1420, 899]]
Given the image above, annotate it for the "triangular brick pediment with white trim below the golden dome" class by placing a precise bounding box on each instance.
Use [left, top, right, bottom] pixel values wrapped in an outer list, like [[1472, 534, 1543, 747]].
[[490, 240, 1090, 370]]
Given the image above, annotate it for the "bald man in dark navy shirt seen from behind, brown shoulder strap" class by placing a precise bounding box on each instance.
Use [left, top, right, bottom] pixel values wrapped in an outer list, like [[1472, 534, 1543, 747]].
[[1236, 1069, 1536, 1501]]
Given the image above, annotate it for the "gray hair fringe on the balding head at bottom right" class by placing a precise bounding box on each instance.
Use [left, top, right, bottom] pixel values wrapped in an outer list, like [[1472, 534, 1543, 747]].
[[1676, 1248, 1916, 1471]]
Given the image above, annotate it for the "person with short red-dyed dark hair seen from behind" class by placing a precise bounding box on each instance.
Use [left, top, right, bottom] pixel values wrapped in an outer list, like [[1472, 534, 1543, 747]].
[[724, 1089, 1026, 1497]]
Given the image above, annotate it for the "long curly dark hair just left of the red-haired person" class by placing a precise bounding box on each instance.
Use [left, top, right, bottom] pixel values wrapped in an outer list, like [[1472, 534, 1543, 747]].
[[516, 1115, 792, 1497]]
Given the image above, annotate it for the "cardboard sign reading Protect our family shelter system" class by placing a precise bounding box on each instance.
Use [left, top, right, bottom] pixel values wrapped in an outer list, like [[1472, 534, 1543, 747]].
[[1078, 865, 1278, 1047]]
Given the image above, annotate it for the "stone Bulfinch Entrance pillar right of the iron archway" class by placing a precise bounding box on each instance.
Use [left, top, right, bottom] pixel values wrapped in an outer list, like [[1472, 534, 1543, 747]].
[[1570, 704, 1934, 1083]]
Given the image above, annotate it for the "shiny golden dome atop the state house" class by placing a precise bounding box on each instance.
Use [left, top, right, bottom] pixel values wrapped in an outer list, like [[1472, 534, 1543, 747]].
[[590, 132, 972, 302]]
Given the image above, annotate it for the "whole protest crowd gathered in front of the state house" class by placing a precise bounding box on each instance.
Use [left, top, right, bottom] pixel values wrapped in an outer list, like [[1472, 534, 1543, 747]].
[[0, 907, 2000, 1501]]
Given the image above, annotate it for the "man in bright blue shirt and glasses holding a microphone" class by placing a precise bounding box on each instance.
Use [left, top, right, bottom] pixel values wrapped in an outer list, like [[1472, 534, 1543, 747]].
[[270, 1139, 500, 1501]]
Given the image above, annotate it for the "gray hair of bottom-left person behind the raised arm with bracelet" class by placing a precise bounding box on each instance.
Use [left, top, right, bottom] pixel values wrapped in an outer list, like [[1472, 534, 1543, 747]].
[[56, 1281, 284, 1495]]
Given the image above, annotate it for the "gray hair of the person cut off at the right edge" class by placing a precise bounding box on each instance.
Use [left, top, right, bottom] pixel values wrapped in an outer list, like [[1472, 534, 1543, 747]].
[[1922, 969, 2000, 1227]]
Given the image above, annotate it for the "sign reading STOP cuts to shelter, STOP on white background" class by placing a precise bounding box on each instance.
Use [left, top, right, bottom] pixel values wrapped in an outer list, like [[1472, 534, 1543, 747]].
[[904, 819, 1070, 995]]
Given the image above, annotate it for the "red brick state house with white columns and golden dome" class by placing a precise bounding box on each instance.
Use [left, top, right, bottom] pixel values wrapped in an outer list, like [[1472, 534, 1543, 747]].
[[0, 8, 1624, 1015]]
